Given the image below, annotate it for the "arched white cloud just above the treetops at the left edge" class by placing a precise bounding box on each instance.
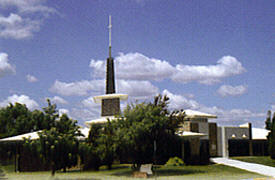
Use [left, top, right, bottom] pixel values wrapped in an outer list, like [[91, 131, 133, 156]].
[[0, 94, 39, 110]]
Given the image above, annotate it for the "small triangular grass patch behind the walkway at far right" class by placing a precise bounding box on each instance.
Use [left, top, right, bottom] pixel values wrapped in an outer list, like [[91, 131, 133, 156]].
[[231, 156, 275, 167]]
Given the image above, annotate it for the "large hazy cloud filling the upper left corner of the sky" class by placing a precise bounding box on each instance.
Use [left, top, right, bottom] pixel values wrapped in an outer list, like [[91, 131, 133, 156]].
[[0, 0, 56, 39]]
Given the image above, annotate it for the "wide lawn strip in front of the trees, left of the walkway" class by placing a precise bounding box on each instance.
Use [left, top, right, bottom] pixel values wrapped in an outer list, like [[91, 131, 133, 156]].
[[0, 164, 264, 180]]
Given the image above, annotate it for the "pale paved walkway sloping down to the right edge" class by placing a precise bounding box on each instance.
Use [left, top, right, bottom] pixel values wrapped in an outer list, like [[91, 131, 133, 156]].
[[211, 158, 275, 177]]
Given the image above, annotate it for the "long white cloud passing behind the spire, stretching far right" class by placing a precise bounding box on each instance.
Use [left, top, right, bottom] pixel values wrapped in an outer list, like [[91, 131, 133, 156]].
[[90, 53, 245, 84]]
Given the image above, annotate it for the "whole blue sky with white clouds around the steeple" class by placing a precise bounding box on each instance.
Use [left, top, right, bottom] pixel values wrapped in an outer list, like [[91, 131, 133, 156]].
[[0, 0, 275, 127]]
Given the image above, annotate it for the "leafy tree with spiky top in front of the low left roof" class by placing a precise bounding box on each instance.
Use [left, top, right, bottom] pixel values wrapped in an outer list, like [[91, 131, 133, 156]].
[[25, 100, 81, 175]]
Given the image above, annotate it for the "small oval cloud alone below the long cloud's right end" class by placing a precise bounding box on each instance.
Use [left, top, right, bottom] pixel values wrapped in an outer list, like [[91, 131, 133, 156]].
[[217, 85, 247, 97]]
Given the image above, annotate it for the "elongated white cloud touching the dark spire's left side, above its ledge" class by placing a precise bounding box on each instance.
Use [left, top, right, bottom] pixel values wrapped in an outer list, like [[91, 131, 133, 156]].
[[50, 80, 105, 96]]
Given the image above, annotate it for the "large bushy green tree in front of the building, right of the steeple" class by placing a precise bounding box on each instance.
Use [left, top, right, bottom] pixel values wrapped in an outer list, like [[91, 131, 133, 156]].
[[112, 95, 185, 169]]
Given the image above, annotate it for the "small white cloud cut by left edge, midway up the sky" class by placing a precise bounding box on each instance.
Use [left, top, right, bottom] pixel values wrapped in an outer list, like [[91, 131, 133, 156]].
[[0, 53, 15, 78]]
